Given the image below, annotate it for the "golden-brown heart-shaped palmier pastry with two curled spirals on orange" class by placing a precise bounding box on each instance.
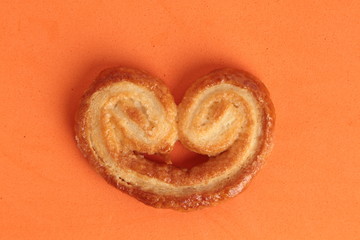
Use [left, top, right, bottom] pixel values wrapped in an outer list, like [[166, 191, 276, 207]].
[[75, 68, 275, 210]]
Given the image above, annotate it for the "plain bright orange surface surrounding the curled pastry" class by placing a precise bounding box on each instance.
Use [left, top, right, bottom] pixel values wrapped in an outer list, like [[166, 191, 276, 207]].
[[0, 0, 360, 240]]
